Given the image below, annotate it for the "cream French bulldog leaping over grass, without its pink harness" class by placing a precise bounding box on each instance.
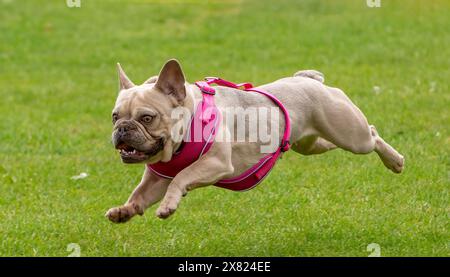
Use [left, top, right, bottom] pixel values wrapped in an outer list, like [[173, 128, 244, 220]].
[[106, 59, 404, 223]]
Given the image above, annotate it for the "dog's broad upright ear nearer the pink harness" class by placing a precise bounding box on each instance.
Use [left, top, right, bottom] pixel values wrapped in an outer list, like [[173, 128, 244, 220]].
[[155, 59, 186, 103]]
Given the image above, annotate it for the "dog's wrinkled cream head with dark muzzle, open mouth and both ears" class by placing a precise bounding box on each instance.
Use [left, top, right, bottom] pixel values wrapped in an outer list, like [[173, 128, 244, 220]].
[[112, 60, 186, 163]]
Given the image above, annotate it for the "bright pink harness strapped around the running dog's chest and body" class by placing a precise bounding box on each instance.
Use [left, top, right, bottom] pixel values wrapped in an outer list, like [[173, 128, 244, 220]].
[[147, 77, 291, 191]]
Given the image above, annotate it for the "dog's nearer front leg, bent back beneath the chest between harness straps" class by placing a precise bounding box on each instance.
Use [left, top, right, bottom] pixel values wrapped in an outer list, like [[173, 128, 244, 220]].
[[156, 146, 234, 219]]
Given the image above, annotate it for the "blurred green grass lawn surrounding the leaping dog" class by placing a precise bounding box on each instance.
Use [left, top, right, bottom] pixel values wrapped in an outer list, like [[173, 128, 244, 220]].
[[0, 0, 450, 256]]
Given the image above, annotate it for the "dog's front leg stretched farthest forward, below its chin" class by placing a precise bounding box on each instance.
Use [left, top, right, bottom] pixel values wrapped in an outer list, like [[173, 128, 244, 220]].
[[106, 167, 170, 223]]
